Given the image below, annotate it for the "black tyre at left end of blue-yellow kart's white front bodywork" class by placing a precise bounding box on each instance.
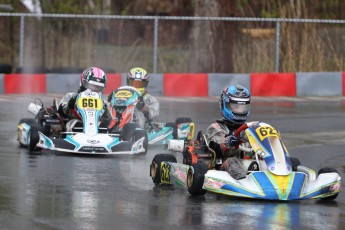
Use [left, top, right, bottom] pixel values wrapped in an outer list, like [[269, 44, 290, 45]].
[[187, 161, 208, 196]]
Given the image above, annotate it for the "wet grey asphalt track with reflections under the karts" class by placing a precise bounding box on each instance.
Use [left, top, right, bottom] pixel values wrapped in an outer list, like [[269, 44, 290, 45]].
[[0, 95, 345, 230]]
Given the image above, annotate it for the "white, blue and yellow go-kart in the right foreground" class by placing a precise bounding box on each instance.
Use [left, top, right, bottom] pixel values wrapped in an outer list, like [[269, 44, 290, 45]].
[[150, 122, 341, 200]]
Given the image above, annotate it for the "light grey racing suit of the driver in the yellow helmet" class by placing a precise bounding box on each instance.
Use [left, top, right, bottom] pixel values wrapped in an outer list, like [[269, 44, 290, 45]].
[[134, 92, 159, 130]]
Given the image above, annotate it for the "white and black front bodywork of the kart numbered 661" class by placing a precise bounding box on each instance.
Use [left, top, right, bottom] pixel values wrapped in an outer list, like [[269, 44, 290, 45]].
[[18, 90, 148, 155]]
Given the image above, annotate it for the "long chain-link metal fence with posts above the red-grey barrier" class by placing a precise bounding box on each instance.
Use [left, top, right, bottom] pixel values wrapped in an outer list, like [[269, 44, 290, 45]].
[[0, 13, 345, 73]]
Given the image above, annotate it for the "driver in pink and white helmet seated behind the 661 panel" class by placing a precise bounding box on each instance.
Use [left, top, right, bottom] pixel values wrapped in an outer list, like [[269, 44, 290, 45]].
[[58, 67, 111, 131]]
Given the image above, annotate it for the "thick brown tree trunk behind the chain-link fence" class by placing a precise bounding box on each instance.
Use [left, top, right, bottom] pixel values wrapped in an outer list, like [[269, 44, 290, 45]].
[[189, 0, 236, 73]]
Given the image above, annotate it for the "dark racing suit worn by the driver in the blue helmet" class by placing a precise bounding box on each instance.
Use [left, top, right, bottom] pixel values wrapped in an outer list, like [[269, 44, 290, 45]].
[[205, 119, 248, 179]]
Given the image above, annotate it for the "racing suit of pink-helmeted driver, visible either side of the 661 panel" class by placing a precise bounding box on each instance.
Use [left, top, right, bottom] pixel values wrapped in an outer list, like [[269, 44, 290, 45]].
[[58, 91, 111, 132]]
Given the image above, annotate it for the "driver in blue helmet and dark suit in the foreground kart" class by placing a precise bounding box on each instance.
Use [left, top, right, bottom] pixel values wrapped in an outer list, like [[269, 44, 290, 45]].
[[205, 85, 251, 179]]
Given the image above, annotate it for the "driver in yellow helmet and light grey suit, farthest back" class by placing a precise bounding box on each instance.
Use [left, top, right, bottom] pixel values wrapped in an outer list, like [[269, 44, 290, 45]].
[[108, 67, 159, 130]]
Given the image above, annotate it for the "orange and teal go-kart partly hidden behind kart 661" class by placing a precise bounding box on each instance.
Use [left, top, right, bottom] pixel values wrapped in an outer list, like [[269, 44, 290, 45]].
[[108, 86, 194, 144]]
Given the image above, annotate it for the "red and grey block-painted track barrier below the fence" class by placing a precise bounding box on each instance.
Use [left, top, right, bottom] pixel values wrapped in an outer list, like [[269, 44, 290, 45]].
[[0, 72, 345, 97]]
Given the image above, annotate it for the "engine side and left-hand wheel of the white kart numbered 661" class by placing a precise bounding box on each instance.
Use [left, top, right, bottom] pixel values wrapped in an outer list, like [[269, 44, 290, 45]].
[[17, 98, 68, 151]]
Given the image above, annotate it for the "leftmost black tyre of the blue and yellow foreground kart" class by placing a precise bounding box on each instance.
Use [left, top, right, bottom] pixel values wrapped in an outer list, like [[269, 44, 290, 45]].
[[150, 153, 177, 185]]
